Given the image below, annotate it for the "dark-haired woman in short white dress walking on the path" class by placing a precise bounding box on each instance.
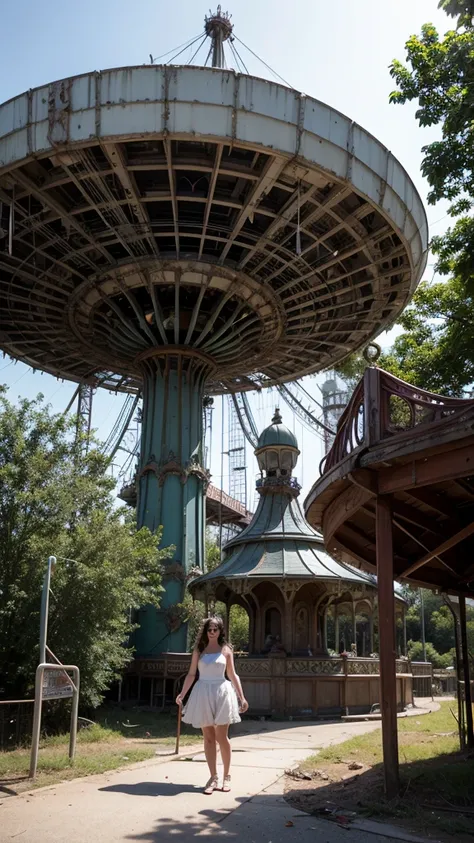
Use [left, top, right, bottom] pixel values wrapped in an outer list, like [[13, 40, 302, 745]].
[[176, 617, 249, 795]]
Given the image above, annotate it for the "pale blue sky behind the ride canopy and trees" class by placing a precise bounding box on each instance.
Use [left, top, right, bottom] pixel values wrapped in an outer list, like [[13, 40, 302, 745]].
[[0, 0, 452, 501]]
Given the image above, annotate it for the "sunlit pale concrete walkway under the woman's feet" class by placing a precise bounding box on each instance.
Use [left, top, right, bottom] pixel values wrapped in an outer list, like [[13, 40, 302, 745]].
[[0, 700, 438, 843]]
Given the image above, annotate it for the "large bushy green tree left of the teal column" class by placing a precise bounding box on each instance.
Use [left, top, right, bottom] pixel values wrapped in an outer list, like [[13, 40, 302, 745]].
[[0, 390, 169, 706]]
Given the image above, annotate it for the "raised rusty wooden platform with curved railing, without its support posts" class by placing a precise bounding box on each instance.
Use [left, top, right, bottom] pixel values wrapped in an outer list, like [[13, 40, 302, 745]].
[[305, 367, 474, 597]]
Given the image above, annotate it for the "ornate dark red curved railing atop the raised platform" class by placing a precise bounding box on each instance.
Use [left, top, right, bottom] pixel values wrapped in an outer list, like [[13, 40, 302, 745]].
[[320, 367, 474, 474]]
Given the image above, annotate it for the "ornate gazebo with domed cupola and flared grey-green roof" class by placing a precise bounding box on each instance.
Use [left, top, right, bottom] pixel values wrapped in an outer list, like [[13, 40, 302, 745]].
[[189, 408, 411, 713]]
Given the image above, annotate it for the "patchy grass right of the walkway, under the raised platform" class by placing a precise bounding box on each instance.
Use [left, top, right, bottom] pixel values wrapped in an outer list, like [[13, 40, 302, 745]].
[[287, 701, 474, 840]]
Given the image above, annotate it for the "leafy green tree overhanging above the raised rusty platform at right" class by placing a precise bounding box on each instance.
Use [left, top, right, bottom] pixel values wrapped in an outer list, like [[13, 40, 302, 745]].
[[380, 0, 474, 395]]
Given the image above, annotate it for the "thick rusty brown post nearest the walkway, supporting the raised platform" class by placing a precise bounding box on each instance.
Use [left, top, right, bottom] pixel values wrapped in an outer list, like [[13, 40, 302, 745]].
[[376, 497, 400, 799]]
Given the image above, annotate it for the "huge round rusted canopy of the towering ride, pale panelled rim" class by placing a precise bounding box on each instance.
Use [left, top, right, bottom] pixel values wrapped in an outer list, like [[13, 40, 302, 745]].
[[0, 66, 427, 393]]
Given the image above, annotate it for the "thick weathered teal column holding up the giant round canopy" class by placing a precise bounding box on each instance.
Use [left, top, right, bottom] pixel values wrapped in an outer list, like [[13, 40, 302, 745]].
[[134, 346, 214, 656]]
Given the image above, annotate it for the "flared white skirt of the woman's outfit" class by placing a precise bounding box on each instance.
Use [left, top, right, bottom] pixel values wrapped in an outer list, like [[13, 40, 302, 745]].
[[182, 679, 240, 729]]
